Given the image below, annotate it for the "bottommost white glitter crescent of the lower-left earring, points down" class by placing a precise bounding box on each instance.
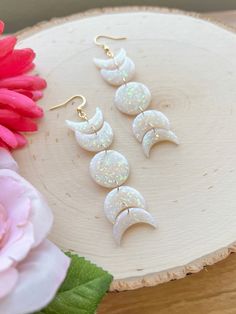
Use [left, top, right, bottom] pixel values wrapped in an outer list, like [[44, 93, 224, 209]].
[[113, 208, 157, 244]]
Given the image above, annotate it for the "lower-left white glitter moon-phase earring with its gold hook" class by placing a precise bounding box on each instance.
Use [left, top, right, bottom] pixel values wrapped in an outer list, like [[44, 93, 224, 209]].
[[50, 95, 156, 244]]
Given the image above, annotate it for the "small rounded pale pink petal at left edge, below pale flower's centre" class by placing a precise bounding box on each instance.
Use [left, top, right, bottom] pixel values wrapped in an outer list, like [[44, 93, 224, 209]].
[[0, 267, 18, 298]]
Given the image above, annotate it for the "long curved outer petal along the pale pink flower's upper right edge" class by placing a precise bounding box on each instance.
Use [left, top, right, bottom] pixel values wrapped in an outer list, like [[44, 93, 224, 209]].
[[0, 169, 53, 248]]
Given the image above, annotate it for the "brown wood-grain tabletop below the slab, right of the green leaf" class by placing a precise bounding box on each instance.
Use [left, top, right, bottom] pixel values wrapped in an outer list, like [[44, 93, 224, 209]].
[[98, 254, 236, 314]]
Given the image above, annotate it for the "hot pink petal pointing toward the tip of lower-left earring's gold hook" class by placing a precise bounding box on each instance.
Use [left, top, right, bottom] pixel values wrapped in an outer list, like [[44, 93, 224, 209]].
[[0, 88, 43, 118]]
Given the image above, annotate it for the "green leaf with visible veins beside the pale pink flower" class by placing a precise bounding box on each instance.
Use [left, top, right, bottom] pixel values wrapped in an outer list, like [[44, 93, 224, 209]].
[[37, 253, 112, 314]]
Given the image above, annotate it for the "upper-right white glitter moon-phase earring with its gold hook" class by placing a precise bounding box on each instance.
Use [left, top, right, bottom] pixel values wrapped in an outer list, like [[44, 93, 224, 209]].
[[94, 35, 179, 157]]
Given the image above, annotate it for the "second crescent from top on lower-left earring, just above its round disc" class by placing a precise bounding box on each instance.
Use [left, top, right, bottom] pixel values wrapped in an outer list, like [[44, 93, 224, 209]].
[[75, 121, 113, 152]]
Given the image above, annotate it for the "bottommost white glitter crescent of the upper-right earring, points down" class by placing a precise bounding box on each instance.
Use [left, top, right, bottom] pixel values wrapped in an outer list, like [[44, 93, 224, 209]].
[[142, 128, 179, 157]]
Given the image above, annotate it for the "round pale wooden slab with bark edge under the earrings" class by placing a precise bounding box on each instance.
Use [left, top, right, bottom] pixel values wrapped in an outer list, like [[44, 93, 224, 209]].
[[15, 8, 236, 290]]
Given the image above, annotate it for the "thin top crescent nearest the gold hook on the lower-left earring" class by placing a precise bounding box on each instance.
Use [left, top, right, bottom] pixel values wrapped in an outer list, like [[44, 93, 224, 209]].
[[66, 107, 104, 134]]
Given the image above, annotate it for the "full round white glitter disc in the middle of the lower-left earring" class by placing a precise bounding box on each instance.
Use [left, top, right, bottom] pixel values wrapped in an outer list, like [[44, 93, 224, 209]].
[[89, 150, 129, 188]]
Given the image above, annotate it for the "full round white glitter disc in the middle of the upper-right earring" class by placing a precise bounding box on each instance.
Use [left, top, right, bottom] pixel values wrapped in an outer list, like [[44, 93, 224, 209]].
[[114, 82, 151, 115]]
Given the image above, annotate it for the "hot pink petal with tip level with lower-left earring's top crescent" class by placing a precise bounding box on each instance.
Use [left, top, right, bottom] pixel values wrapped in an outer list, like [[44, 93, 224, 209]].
[[0, 109, 38, 132]]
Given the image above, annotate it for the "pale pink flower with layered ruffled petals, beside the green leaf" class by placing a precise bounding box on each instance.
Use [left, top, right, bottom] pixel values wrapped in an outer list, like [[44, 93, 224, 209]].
[[0, 148, 69, 314]]
